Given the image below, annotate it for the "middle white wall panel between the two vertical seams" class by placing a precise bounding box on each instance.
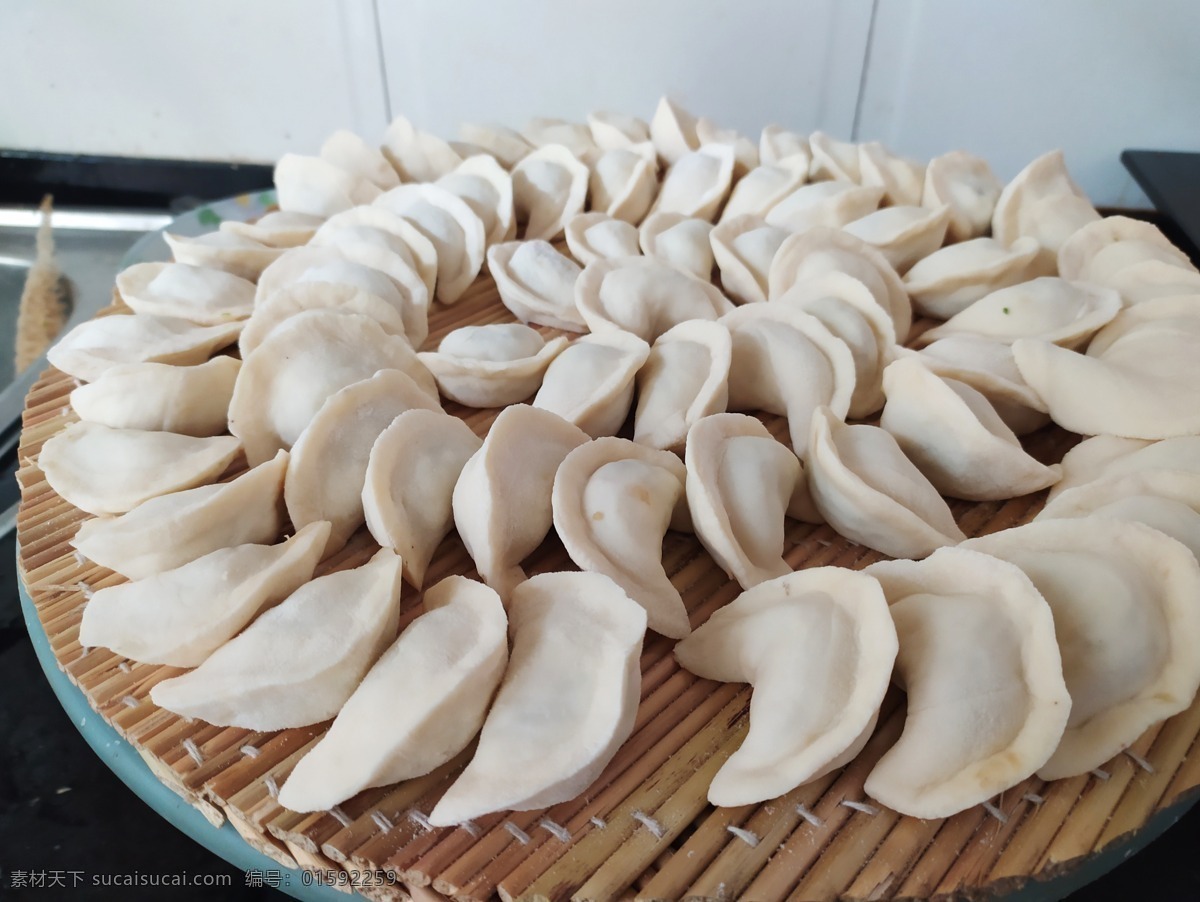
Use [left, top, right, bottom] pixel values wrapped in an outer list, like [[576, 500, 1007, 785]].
[[379, 0, 871, 138]]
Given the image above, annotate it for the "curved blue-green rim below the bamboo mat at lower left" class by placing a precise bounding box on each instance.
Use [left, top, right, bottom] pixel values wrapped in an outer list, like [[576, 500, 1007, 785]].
[[17, 546, 347, 902]]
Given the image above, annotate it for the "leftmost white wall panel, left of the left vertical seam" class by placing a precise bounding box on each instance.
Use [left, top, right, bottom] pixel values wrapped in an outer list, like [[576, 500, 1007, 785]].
[[0, 0, 388, 162]]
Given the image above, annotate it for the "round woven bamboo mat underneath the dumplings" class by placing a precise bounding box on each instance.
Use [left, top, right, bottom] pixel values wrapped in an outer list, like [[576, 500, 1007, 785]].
[[18, 277, 1200, 900]]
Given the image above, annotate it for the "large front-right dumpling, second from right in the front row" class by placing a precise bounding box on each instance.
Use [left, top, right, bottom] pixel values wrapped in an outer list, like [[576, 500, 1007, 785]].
[[865, 548, 1070, 818]]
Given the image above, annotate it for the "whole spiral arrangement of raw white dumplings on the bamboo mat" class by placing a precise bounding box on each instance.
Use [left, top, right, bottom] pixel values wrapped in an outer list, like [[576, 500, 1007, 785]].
[[38, 100, 1200, 825]]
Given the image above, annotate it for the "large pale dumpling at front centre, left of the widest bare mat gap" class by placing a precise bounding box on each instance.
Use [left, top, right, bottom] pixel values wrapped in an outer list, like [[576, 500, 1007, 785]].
[[430, 573, 646, 826]]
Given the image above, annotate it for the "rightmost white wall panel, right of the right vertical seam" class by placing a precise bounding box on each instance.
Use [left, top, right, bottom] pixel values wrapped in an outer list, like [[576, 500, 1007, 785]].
[[856, 0, 1200, 206]]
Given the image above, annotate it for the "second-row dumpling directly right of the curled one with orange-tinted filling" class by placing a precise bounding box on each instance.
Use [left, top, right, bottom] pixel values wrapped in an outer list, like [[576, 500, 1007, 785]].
[[684, 414, 804, 589]]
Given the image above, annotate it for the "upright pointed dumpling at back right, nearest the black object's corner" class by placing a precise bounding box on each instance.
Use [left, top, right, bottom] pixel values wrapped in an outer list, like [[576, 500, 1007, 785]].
[[991, 150, 1100, 267]]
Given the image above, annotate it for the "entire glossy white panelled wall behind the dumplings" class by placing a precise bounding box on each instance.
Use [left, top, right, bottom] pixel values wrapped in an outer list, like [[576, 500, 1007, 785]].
[[0, 0, 1200, 205]]
